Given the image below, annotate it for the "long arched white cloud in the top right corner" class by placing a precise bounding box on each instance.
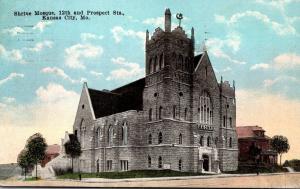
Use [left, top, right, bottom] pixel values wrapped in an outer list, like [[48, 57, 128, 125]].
[[215, 11, 296, 35]]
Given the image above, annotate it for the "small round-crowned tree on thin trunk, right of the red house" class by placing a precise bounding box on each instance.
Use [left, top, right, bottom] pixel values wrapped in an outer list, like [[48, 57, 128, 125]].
[[271, 135, 290, 165]]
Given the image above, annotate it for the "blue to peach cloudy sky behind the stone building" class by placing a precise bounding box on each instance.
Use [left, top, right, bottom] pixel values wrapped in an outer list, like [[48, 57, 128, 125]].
[[0, 0, 300, 163]]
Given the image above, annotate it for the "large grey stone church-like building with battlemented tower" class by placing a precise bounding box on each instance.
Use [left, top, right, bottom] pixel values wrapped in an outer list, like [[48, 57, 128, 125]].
[[73, 9, 238, 173]]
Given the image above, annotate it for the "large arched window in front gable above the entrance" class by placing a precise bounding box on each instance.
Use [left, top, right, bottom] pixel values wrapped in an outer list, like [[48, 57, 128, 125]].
[[199, 91, 213, 124]]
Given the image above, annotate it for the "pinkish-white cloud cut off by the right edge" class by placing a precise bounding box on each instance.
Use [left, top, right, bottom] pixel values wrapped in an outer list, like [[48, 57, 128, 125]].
[[273, 53, 300, 69]]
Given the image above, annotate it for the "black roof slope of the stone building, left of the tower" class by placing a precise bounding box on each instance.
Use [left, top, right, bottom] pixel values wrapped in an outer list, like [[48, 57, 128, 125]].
[[88, 78, 145, 119]]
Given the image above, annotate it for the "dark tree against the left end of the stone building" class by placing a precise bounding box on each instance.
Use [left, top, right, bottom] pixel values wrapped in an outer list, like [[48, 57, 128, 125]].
[[64, 134, 82, 172]]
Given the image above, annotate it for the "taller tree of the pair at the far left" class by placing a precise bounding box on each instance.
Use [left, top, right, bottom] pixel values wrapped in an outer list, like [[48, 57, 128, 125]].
[[26, 133, 47, 180]]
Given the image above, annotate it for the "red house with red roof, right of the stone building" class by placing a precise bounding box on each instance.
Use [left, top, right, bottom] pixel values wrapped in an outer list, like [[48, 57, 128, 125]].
[[236, 126, 277, 165]]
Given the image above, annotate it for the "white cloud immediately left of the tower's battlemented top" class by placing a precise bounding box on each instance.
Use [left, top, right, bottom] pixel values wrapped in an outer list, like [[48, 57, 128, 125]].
[[111, 26, 146, 43]]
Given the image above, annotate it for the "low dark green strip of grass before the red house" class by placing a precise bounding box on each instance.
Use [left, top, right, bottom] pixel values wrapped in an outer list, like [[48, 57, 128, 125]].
[[225, 165, 287, 174]]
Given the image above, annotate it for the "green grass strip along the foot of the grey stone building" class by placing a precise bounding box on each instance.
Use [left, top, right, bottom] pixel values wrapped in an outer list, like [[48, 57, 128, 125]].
[[57, 170, 203, 179]]
